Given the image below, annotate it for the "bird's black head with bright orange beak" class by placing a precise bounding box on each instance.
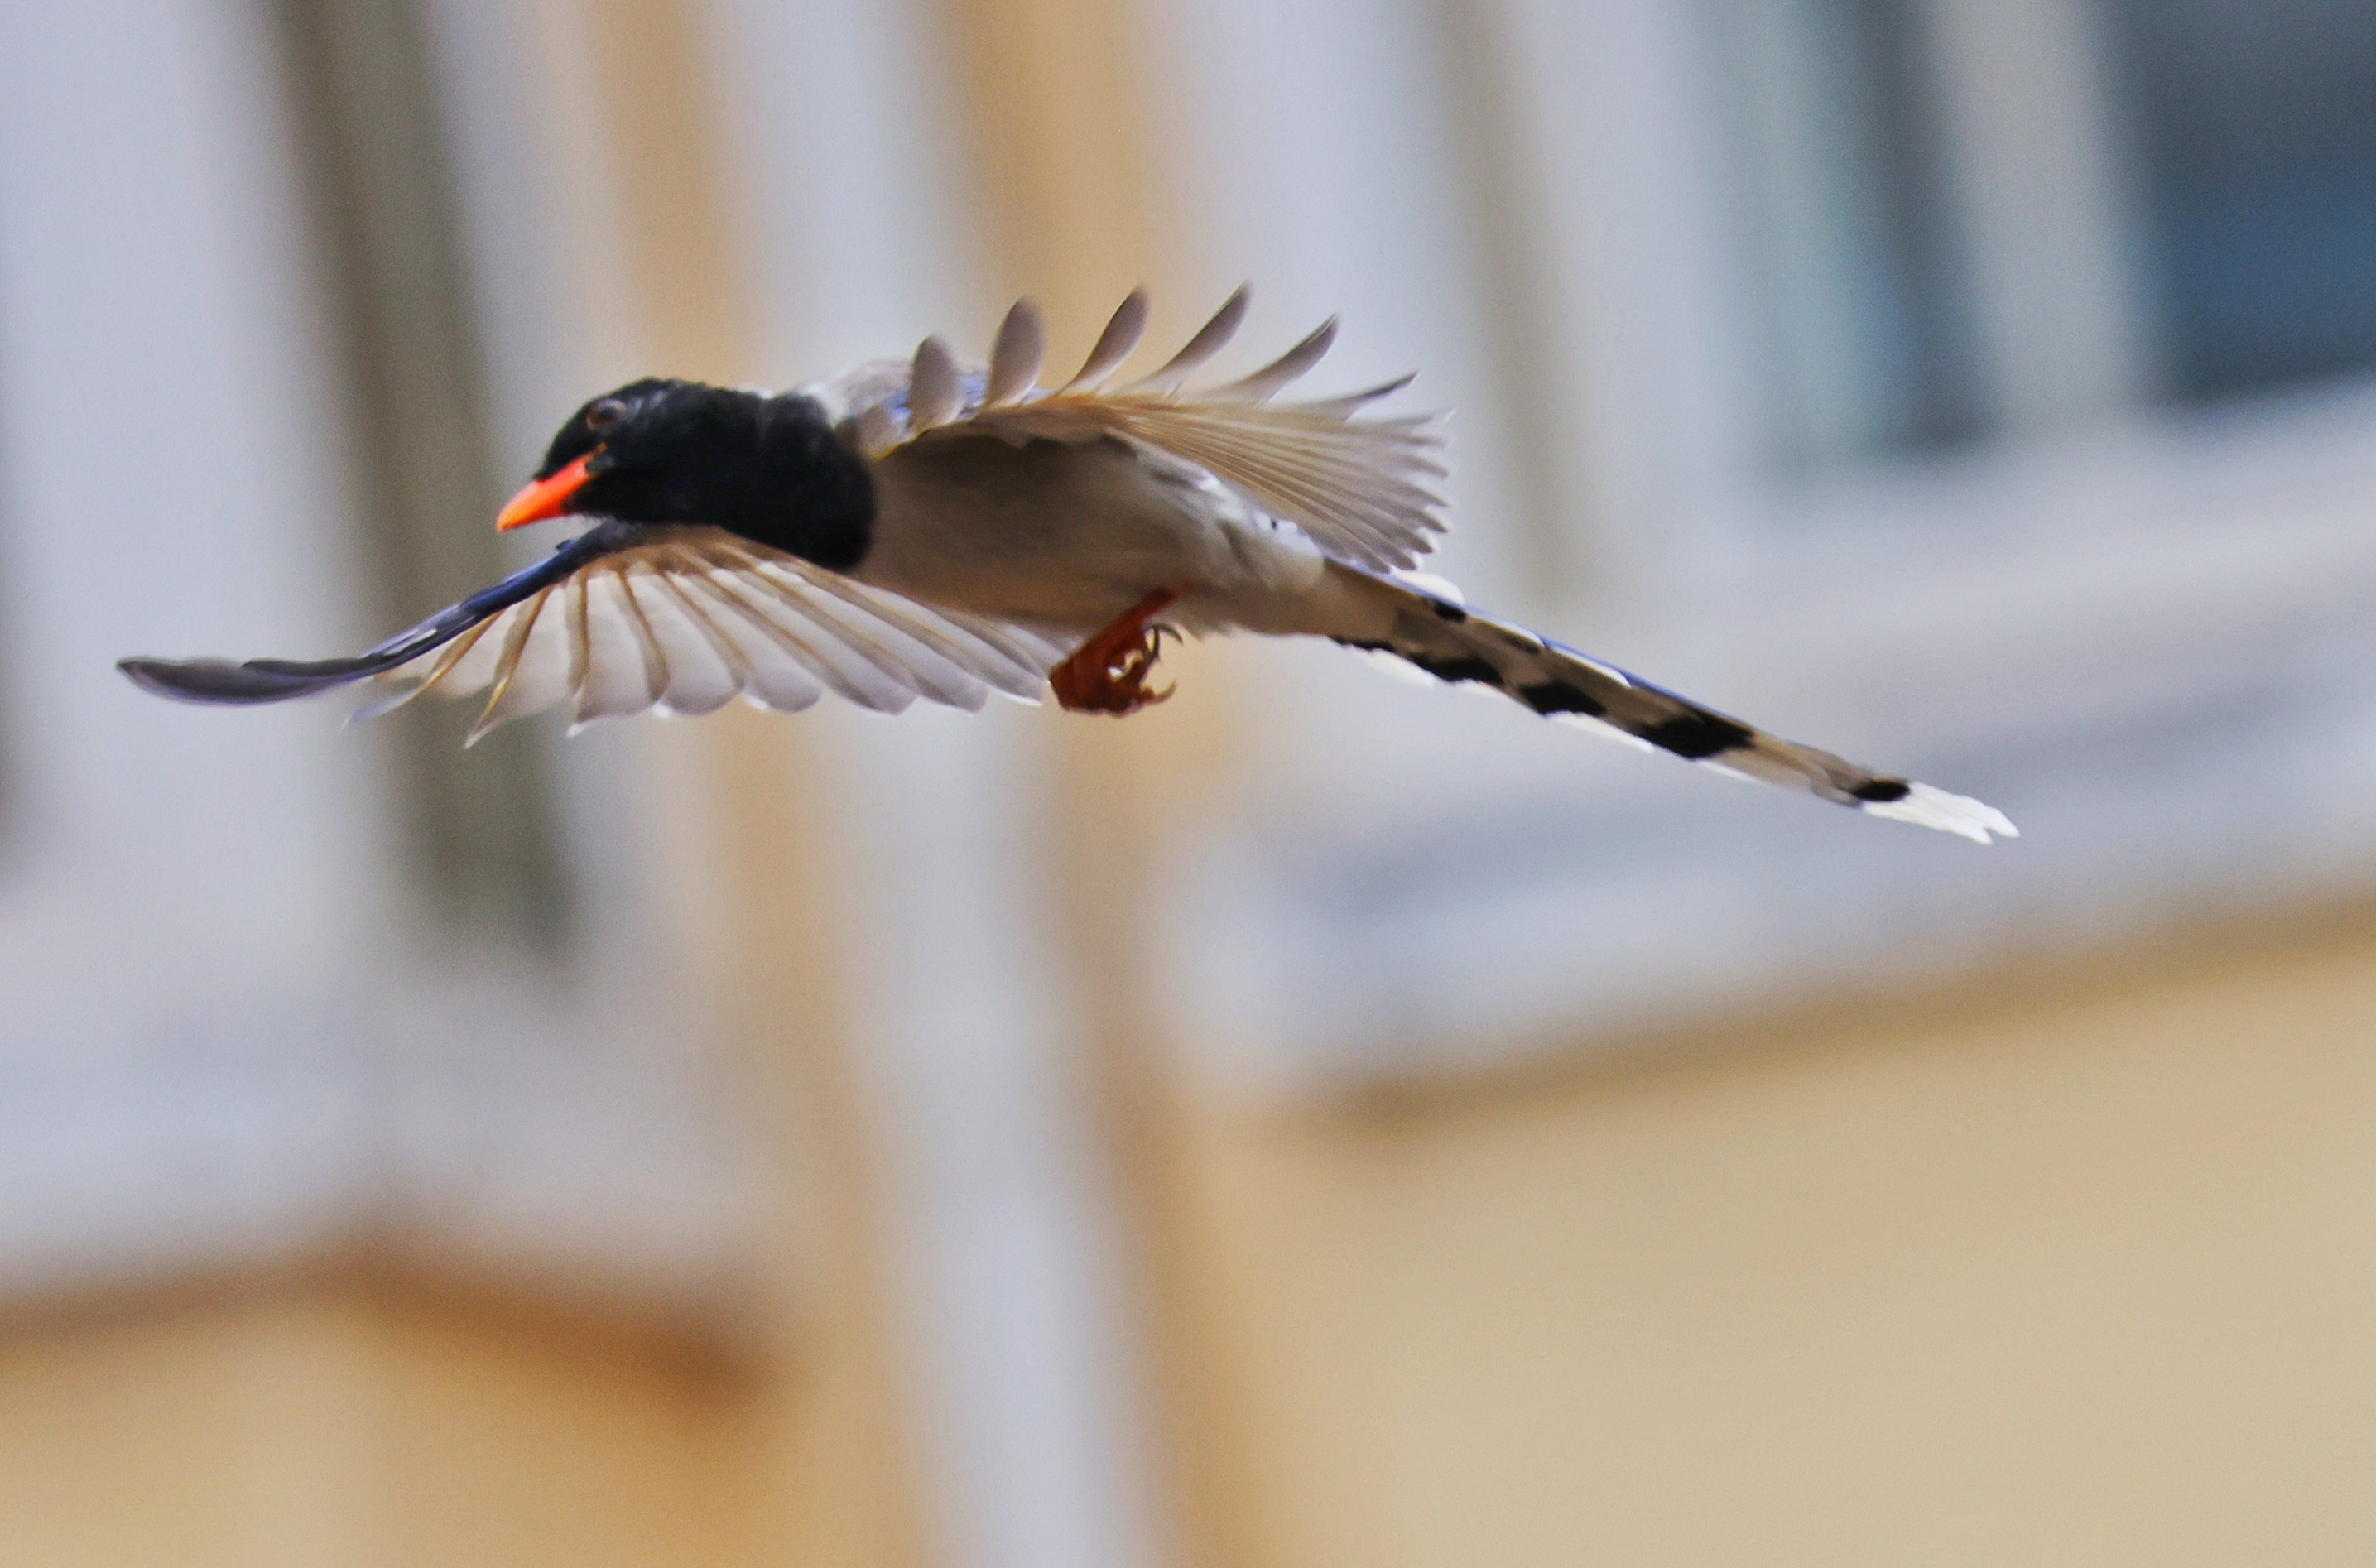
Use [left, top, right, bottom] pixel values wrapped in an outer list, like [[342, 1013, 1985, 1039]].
[[497, 378, 874, 570]]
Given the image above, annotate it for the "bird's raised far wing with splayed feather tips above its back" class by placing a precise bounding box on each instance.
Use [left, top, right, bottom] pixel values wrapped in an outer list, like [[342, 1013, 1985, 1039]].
[[841, 287, 1447, 570]]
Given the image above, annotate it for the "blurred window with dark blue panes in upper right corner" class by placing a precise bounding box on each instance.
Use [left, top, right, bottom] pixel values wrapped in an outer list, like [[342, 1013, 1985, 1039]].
[[1713, 0, 2376, 465]]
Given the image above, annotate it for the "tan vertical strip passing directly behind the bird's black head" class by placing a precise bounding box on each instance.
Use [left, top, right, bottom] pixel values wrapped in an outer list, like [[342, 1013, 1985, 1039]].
[[563, 0, 926, 1568]]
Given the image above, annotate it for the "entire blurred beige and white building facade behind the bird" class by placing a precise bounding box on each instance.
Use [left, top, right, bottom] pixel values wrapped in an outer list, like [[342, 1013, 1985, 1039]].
[[0, 0, 2376, 1568]]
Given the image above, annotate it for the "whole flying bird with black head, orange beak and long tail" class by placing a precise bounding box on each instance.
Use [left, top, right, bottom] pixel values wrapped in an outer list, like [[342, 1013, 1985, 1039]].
[[119, 287, 2015, 844]]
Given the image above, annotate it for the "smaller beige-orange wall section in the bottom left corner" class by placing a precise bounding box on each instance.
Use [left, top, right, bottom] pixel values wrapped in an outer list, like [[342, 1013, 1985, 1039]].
[[0, 1283, 760, 1568]]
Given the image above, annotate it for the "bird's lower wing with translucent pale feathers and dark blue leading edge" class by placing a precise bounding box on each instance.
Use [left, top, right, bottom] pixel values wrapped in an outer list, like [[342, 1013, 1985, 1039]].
[[121, 522, 1067, 741]]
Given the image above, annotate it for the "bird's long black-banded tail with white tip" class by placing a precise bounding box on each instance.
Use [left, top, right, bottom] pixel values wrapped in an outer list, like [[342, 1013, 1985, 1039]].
[[1309, 560, 2020, 844]]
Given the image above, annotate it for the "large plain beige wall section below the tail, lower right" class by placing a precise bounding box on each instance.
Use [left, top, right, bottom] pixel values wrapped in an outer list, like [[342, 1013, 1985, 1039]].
[[1154, 921, 2376, 1568]]
